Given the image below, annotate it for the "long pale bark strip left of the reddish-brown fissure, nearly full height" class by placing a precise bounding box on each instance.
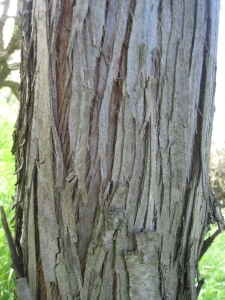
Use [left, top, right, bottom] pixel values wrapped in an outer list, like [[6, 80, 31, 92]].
[[34, 1, 58, 284]]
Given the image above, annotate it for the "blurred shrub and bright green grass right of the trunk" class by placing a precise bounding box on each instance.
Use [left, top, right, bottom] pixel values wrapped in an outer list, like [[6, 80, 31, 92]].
[[198, 146, 225, 300]]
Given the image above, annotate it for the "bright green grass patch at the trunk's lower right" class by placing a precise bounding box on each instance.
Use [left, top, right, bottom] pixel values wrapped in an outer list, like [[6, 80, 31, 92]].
[[198, 226, 225, 300]]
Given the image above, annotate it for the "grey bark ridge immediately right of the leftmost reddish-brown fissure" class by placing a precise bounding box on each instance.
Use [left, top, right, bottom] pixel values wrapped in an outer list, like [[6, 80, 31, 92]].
[[69, 1, 105, 199]]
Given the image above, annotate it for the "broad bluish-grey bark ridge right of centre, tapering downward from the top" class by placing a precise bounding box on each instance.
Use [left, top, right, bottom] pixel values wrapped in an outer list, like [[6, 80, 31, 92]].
[[123, 1, 158, 231]]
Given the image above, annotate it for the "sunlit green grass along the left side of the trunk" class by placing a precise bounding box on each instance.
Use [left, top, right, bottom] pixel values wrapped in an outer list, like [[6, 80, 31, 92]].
[[0, 99, 17, 300]]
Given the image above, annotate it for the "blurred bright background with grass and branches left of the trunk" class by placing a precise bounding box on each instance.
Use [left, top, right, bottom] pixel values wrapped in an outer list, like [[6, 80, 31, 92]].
[[0, 0, 20, 300]]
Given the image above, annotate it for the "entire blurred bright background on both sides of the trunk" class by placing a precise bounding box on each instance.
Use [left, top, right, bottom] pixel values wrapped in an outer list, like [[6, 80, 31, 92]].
[[0, 0, 225, 300]]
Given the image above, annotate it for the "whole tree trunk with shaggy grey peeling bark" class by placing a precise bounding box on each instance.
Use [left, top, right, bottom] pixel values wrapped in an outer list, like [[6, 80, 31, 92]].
[[11, 0, 219, 300]]
